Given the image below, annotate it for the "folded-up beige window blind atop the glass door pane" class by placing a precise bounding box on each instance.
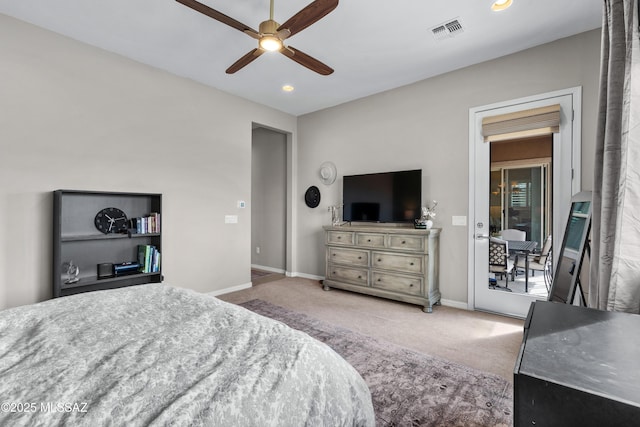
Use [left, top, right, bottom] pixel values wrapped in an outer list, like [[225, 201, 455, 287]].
[[482, 104, 560, 142]]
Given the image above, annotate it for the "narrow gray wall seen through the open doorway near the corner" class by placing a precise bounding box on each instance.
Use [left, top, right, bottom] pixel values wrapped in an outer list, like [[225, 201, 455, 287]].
[[251, 128, 287, 272]]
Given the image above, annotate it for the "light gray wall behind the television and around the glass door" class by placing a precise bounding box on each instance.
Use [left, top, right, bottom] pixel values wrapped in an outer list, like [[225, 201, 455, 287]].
[[297, 30, 600, 302]]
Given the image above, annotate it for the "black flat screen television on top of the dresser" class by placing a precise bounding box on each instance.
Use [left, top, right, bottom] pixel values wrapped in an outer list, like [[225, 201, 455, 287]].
[[342, 169, 422, 222]]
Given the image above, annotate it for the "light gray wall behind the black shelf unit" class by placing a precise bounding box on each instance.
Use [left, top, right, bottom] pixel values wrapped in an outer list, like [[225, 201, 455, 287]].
[[0, 15, 296, 309]]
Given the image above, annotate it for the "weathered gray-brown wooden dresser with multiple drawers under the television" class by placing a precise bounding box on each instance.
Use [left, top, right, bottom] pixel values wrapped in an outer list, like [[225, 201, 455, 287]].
[[323, 225, 441, 313]]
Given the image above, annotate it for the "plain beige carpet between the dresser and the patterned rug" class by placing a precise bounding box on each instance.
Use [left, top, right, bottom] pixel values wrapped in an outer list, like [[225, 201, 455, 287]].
[[219, 278, 523, 381]]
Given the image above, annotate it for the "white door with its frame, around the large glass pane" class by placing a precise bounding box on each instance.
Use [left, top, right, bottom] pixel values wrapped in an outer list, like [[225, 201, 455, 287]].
[[468, 88, 582, 317]]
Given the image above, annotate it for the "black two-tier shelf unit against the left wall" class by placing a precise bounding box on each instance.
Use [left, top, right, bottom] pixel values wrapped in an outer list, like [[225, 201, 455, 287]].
[[52, 190, 163, 298]]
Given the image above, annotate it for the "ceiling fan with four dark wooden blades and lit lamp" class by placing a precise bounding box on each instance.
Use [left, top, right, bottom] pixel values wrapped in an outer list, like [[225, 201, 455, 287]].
[[176, 0, 338, 76]]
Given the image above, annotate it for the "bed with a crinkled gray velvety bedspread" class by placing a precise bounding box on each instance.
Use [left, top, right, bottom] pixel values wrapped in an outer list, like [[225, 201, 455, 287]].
[[0, 284, 375, 426]]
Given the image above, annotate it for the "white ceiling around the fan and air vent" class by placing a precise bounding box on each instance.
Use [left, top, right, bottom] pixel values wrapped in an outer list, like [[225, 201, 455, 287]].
[[0, 0, 602, 115]]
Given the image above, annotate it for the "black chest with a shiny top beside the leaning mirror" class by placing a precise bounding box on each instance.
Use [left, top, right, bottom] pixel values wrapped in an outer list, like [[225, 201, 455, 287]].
[[513, 301, 640, 427]]
